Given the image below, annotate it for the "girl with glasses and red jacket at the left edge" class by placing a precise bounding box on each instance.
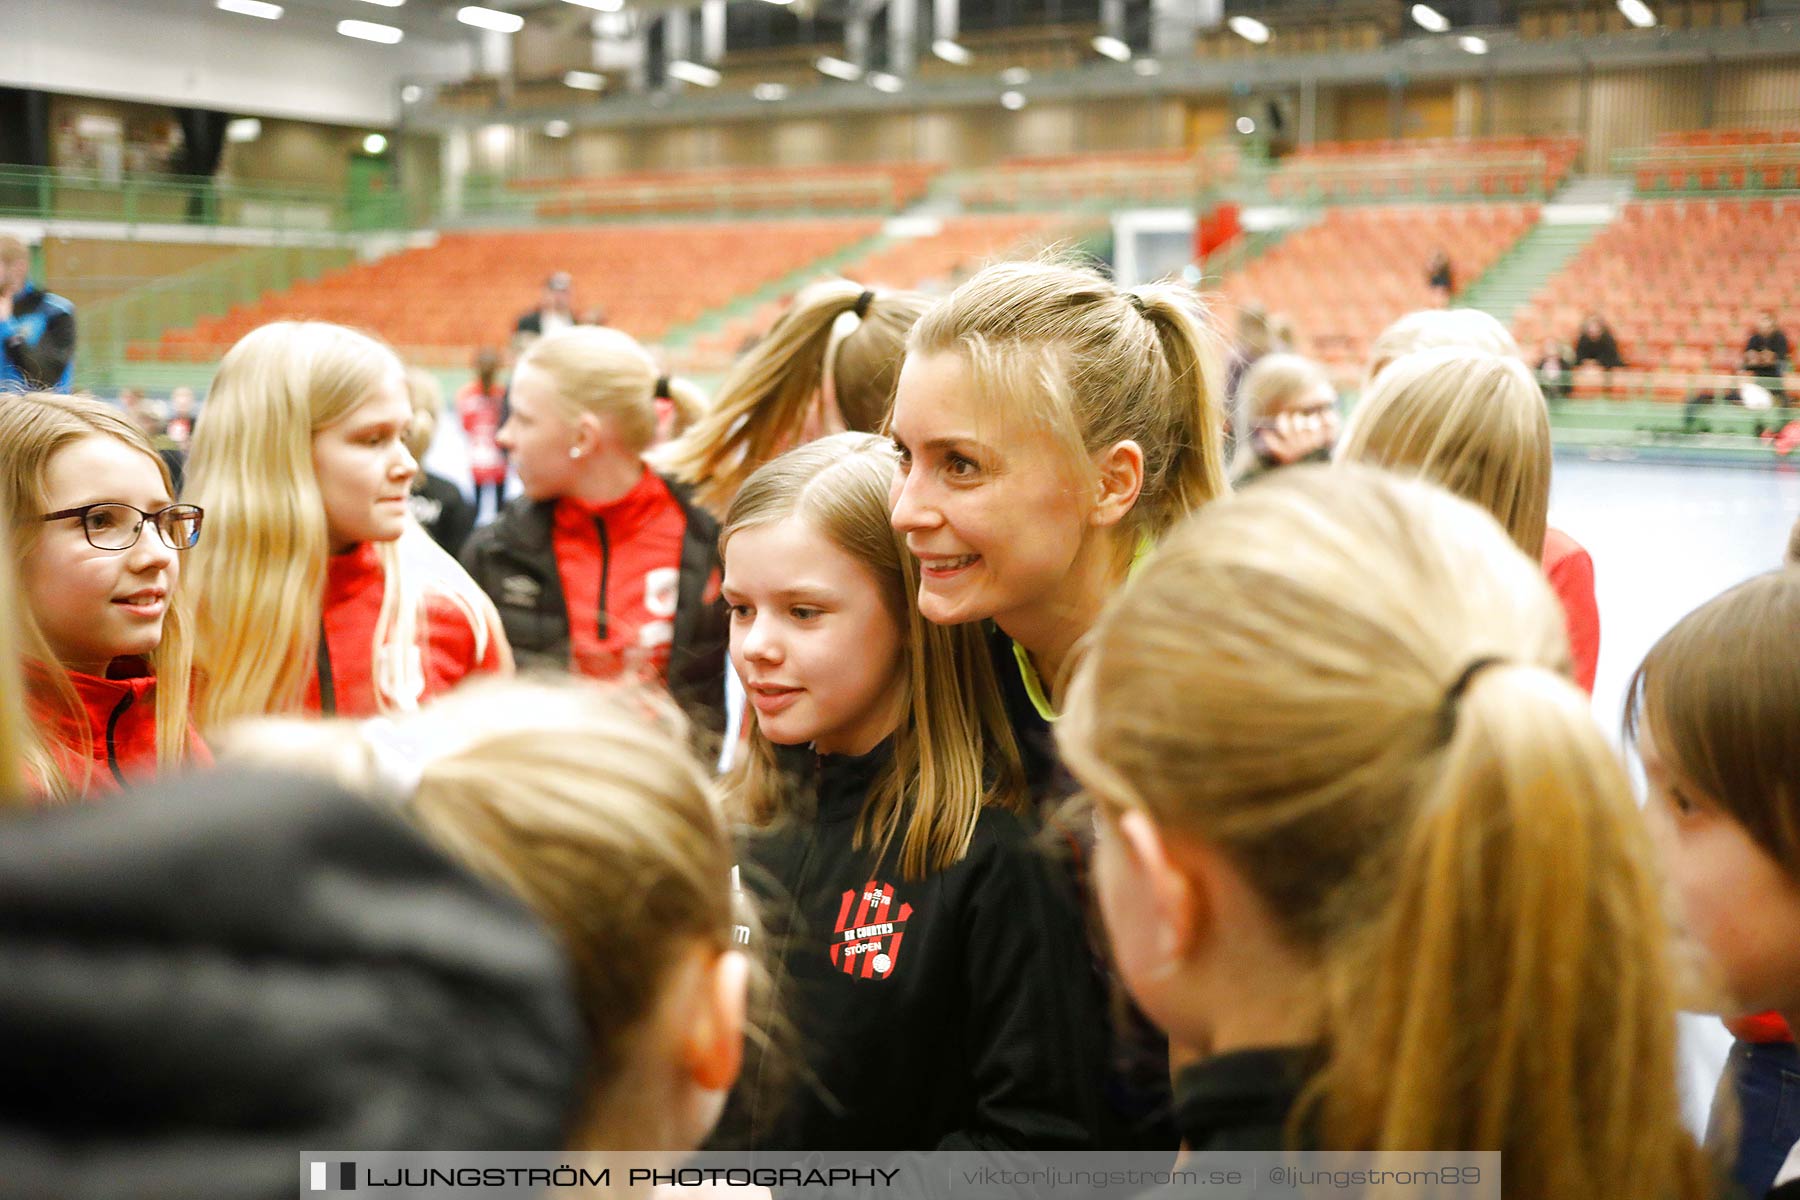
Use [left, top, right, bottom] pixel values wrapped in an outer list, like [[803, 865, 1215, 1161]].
[[0, 394, 207, 799]]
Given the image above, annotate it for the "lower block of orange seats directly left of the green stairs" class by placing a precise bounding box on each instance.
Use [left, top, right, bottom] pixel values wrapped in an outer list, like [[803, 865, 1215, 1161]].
[[1219, 203, 1539, 378]]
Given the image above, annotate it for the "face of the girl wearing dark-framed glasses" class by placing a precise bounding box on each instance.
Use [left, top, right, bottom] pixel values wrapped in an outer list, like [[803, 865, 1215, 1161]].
[[22, 434, 182, 675]]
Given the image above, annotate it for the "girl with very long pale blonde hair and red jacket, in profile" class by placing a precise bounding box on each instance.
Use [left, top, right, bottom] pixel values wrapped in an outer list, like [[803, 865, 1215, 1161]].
[[187, 322, 511, 730]]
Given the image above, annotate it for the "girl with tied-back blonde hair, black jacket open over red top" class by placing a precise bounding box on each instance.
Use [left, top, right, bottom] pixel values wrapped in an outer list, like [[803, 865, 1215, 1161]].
[[463, 326, 725, 734]]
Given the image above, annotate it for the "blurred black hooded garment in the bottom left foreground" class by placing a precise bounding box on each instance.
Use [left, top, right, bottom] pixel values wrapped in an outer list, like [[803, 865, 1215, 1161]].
[[0, 774, 585, 1200]]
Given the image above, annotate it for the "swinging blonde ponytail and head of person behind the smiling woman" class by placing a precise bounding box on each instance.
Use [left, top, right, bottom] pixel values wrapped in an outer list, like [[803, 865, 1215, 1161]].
[[657, 279, 929, 513]]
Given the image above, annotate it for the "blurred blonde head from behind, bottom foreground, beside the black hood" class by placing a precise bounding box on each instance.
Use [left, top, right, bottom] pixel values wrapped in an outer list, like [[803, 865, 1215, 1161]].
[[221, 680, 754, 1151]]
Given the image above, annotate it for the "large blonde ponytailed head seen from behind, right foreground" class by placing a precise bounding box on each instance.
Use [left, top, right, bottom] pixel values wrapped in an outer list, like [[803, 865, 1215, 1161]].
[[1057, 466, 1715, 1200]]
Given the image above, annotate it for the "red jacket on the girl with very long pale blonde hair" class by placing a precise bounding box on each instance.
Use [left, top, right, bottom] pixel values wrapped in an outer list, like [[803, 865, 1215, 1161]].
[[306, 542, 504, 716]]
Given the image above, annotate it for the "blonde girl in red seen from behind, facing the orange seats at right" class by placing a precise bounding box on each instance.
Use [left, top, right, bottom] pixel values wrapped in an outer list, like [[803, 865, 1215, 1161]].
[[1337, 341, 1600, 693]]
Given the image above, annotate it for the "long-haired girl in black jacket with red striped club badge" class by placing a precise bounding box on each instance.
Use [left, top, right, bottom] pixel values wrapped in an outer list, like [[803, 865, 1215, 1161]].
[[720, 434, 1103, 1150]]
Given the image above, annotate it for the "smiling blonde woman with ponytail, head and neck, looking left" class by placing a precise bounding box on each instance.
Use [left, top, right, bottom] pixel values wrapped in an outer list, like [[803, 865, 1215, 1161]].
[[891, 263, 1229, 780]]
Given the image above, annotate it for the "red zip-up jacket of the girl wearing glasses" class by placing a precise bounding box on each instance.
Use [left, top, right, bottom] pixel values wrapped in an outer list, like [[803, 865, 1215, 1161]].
[[27, 658, 212, 793]]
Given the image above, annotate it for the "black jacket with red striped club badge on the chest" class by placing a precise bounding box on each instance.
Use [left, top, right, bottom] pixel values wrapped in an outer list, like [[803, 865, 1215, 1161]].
[[713, 743, 1107, 1151]]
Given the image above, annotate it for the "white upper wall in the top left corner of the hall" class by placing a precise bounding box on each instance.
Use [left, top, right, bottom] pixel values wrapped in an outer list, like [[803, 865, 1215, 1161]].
[[0, 0, 475, 128]]
